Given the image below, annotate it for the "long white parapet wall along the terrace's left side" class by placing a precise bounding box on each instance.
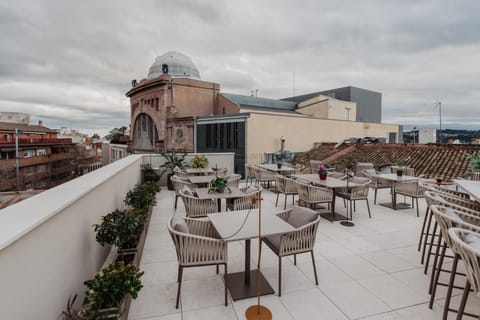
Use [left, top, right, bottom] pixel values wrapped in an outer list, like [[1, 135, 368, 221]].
[[0, 155, 142, 320]]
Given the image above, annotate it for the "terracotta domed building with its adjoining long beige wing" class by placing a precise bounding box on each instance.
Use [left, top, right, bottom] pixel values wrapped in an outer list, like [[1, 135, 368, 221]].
[[127, 52, 401, 172]]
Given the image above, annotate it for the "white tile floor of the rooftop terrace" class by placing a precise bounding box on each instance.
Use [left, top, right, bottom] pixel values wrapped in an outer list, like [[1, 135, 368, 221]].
[[129, 184, 480, 320]]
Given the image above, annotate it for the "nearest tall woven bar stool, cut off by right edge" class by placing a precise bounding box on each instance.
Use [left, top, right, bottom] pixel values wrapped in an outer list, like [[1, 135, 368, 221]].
[[448, 228, 480, 319]]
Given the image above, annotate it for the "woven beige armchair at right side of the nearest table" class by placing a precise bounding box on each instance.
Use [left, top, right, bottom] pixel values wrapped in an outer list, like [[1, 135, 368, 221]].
[[262, 206, 320, 296]]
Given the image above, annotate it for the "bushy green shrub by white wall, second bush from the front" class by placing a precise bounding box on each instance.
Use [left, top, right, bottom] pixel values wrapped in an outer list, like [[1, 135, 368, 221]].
[[93, 209, 145, 249]]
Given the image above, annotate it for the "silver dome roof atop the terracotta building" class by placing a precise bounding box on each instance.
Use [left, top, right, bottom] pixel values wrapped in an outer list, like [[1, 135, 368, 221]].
[[147, 51, 200, 80]]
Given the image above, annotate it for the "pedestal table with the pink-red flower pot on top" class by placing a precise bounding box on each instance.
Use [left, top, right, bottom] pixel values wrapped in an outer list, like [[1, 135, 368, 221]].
[[292, 173, 360, 222]]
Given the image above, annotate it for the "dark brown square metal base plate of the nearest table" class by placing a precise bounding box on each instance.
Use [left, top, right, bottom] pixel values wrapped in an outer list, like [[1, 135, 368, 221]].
[[224, 270, 275, 301]]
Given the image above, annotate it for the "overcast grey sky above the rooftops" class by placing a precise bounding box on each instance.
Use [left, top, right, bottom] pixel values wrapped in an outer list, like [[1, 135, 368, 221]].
[[0, 0, 480, 135]]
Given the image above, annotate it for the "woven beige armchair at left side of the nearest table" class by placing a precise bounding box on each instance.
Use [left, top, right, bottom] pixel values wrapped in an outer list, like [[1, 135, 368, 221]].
[[168, 218, 228, 309]]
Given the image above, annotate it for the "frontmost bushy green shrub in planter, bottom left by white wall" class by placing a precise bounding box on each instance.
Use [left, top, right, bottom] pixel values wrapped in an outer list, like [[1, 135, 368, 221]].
[[83, 262, 143, 319]]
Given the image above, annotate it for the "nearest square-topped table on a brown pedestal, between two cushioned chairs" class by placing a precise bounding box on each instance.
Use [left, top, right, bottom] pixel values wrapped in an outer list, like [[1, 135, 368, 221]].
[[208, 209, 295, 301]]
